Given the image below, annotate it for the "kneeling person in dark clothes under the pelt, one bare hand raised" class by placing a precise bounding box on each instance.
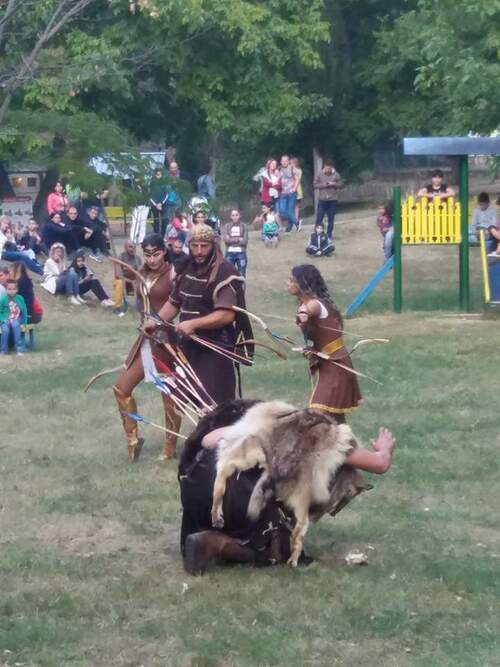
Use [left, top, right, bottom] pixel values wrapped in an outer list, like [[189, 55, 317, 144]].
[[178, 400, 396, 575]]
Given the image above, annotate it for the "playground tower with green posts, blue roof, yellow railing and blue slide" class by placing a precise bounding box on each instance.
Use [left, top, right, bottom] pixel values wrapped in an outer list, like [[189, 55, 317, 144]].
[[346, 137, 500, 315]]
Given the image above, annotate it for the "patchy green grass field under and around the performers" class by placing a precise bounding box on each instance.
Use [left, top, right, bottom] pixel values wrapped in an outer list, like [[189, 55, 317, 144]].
[[0, 219, 500, 667]]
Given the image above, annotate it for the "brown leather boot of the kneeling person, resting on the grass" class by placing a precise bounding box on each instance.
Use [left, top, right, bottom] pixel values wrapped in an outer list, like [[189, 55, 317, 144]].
[[183, 530, 255, 575]]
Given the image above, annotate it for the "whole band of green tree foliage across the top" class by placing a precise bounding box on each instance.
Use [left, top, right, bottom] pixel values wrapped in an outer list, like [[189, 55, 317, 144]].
[[0, 0, 500, 198]]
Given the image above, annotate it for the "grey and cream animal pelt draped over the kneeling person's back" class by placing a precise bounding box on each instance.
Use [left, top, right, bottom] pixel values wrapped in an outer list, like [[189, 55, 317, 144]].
[[212, 401, 369, 567]]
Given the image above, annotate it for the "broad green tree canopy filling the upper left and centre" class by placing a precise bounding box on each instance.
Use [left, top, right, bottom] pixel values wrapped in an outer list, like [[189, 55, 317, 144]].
[[0, 0, 336, 204]]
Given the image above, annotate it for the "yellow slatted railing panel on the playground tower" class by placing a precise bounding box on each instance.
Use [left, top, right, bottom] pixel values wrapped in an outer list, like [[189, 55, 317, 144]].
[[401, 197, 462, 245]]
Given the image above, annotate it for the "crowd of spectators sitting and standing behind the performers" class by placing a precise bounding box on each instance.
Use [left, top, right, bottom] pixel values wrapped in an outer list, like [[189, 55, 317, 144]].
[[0, 155, 500, 354]]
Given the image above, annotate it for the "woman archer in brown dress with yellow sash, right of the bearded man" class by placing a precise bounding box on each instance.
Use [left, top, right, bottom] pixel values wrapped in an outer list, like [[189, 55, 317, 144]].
[[287, 264, 361, 422]]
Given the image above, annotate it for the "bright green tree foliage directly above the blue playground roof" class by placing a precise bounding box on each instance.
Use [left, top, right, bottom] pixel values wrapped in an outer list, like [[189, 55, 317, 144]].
[[365, 0, 500, 135]]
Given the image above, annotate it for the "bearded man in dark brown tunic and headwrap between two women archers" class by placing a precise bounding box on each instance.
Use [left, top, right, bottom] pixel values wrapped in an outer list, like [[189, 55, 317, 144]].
[[148, 224, 252, 404]]
